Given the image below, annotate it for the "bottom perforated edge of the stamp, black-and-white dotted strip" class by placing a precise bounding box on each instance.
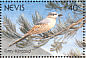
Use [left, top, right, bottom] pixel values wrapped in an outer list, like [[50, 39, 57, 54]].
[[1, 56, 85, 58]]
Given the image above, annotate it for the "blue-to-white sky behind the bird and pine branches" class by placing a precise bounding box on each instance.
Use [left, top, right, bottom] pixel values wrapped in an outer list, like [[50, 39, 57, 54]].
[[2, 2, 83, 55]]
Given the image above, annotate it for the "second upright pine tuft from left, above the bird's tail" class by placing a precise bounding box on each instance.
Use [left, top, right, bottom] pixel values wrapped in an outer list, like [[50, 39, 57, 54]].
[[18, 15, 32, 34]]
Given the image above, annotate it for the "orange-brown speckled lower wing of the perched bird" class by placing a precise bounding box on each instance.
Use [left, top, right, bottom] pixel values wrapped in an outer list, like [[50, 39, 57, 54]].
[[28, 24, 48, 35]]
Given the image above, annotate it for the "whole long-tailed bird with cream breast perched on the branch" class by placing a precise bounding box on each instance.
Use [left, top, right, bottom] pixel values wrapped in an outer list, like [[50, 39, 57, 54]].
[[9, 12, 62, 47]]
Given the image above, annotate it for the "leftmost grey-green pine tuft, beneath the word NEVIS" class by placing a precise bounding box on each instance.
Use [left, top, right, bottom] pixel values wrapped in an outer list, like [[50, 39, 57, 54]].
[[1, 17, 21, 39]]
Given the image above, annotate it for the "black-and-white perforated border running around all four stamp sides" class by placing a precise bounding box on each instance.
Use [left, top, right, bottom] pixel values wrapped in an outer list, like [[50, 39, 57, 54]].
[[0, 0, 86, 58]]
